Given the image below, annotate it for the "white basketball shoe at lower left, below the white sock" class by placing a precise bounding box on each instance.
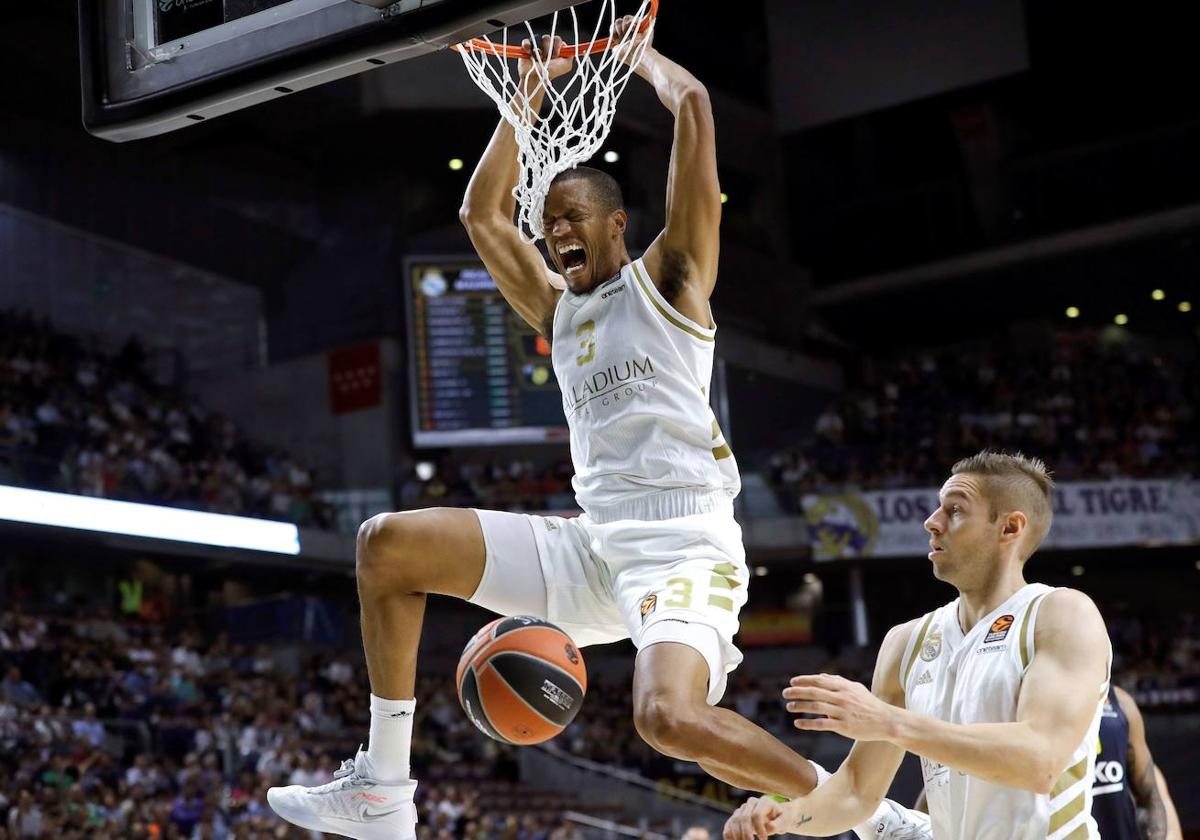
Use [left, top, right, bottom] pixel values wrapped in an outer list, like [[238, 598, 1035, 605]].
[[266, 749, 416, 840]]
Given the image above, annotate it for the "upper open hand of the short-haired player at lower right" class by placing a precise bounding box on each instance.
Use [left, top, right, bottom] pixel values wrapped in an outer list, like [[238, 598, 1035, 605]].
[[784, 673, 895, 740]]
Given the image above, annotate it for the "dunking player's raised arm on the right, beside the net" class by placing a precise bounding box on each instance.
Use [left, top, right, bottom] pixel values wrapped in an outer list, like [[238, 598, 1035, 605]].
[[617, 18, 721, 326]]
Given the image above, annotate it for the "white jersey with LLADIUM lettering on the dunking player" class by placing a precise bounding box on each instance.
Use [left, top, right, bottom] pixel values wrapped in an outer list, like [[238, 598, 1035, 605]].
[[552, 259, 742, 522]]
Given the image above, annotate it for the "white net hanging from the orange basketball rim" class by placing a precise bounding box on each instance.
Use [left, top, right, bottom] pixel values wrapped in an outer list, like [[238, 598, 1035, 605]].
[[458, 0, 654, 242]]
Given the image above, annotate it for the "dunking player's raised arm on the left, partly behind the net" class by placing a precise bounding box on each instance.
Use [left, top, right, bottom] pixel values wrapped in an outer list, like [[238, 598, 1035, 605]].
[[458, 37, 571, 337]]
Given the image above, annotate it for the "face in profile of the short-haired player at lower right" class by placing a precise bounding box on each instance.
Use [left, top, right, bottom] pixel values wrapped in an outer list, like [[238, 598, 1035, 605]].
[[925, 475, 1000, 583]]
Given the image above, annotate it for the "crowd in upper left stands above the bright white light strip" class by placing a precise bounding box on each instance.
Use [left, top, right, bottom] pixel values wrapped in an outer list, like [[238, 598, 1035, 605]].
[[0, 311, 330, 527]]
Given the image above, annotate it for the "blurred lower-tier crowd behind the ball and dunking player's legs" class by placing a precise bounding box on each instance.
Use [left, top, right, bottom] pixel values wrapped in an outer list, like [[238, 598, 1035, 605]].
[[0, 580, 1200, 840]]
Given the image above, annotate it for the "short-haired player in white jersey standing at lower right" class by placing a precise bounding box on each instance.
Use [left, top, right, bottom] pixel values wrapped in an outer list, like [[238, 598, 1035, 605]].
[[725, 451, 1111, 840]]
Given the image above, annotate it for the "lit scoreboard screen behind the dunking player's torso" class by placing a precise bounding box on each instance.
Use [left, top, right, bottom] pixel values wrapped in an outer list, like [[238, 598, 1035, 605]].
[[404, 259, 568, 446]]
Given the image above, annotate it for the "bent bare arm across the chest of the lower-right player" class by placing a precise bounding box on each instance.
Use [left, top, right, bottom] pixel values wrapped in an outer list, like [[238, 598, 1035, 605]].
[[785, 589, 1109, 793]]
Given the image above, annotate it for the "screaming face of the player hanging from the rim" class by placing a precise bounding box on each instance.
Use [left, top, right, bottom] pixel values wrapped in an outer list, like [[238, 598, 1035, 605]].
[[541, 180, 624, 294]]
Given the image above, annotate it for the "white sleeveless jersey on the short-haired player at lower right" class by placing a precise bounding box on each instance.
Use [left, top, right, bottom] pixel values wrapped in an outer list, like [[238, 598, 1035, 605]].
[[900, 583, 1111, 840]]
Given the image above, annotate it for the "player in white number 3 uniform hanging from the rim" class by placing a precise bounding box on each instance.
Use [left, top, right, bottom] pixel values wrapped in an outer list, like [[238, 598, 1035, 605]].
[[269, 18, 924, 840]]
